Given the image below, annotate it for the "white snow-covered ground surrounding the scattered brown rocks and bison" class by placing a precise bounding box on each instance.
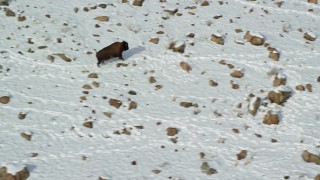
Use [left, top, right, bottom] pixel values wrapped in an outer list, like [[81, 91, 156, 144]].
[[0, 0, 320, 180]]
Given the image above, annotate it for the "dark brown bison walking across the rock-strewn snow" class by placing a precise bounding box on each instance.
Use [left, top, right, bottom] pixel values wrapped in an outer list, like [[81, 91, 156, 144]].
[[96, 41, 129, 67]]
